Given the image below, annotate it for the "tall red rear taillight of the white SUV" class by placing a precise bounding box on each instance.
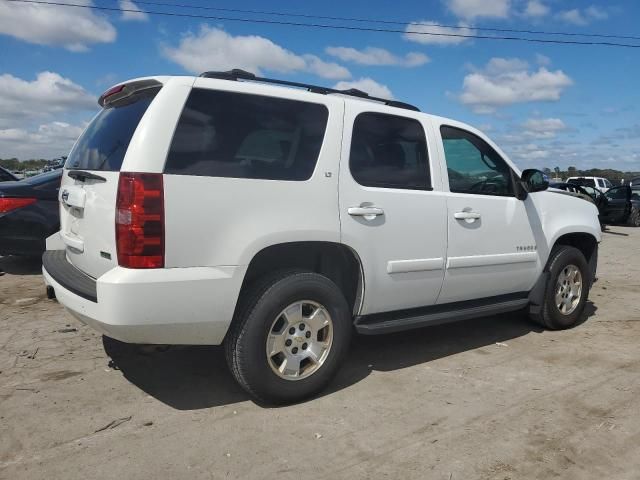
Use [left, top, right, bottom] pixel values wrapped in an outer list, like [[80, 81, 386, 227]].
[[116, 173, 164, 268]]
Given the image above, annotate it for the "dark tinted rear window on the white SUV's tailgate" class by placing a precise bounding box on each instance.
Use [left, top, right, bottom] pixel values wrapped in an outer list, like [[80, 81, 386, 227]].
[[65, 89, 159, 172]]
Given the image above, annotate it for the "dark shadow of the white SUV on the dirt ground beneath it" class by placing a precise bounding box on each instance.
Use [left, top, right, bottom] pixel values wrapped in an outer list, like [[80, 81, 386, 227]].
[[103, 302, 597, 410]]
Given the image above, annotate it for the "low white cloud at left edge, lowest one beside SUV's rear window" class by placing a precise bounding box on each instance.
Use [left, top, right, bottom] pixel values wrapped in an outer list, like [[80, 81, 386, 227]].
[[0, 122, 86, 160]]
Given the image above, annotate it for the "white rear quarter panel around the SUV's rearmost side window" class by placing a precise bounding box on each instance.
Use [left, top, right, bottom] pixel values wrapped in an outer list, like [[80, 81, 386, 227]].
[[164, 79, 344, 267]]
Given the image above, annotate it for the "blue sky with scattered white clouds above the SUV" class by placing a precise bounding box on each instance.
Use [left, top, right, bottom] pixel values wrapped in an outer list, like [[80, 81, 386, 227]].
[[0, 0, 640, 171]]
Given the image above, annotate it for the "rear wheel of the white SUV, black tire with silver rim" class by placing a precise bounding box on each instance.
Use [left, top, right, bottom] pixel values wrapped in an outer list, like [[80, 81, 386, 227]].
[[224, 270, 352, 404]]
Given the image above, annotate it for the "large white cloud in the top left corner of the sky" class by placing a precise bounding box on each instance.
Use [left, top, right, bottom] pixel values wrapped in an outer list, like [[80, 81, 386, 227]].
[[0, 0, 116, 52]]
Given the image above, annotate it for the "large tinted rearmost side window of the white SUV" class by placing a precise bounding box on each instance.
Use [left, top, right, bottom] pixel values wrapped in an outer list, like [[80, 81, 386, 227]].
[[165, 89, 329, 180]]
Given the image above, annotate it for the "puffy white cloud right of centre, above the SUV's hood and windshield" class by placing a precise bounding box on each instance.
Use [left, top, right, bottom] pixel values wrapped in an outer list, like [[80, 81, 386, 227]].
[[459, 58, 573, 113]]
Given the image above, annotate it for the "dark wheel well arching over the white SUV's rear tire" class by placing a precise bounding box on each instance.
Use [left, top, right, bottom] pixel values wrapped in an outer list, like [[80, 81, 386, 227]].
[[242, 242, 363, 313]]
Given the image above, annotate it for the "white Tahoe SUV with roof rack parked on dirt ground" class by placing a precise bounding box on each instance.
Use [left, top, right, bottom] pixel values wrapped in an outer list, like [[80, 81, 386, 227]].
[[43, 70, 600, 402]]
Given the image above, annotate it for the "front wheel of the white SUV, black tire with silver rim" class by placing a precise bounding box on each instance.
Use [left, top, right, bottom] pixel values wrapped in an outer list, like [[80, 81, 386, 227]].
[[531, 245, 591, 330]]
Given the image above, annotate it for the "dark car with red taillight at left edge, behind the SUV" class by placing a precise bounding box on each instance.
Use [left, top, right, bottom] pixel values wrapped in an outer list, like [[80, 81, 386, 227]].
[[0, 170, 62, 256]]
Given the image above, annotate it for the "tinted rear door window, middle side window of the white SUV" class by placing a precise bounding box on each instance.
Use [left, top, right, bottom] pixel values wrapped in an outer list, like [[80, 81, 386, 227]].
[[349, 113, 431, 190]]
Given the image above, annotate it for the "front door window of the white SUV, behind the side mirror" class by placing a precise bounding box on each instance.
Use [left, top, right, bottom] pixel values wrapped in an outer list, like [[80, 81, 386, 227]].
[[440, 126, 513, 195]]
